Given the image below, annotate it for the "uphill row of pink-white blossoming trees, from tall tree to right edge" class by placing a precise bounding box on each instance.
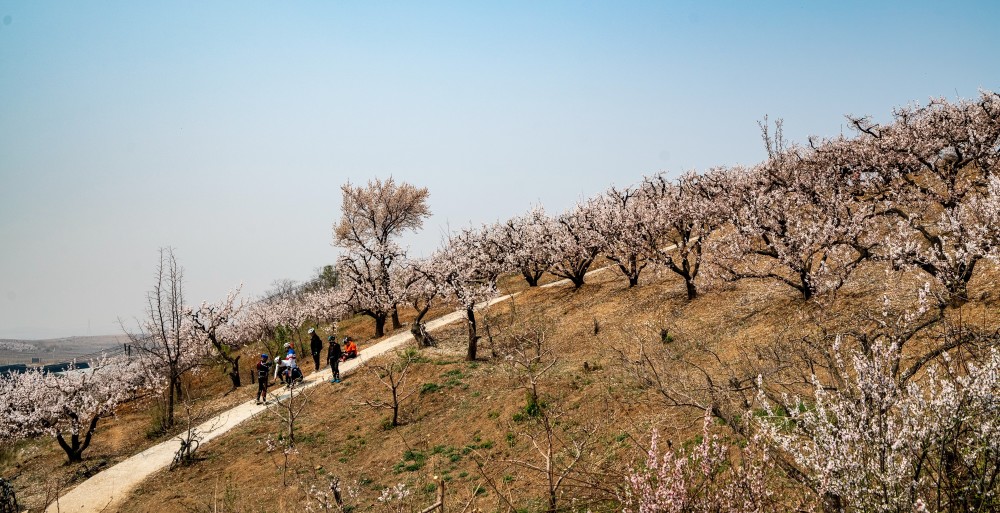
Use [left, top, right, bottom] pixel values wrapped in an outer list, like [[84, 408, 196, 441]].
[[334, 92, 1000, 372]]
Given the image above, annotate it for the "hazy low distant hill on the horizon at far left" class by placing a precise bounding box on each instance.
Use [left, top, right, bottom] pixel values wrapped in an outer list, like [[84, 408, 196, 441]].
[[0, 335, 128, 365]]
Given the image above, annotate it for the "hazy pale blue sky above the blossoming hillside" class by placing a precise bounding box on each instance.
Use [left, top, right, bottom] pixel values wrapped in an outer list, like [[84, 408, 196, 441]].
[[0, 0, 1000, 338]]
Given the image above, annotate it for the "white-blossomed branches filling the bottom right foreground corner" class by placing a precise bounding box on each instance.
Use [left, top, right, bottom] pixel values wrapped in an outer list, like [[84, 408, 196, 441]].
[[760, 339, 1000, 511]]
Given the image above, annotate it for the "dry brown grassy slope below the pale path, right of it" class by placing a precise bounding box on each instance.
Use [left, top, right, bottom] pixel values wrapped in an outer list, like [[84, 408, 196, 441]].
[[107, 270, 852, 511]]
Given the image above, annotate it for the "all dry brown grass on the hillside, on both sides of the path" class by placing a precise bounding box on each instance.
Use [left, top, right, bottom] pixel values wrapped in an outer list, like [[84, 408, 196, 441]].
[[7, 265, 1000, 513]]
